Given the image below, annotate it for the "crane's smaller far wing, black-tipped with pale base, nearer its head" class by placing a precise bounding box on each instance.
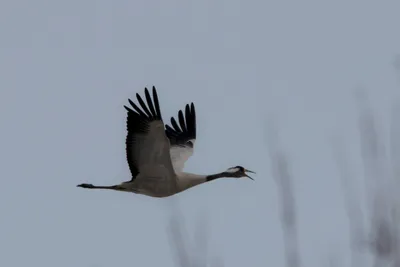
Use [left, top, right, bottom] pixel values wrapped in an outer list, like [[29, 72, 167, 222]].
[[165, 103, 196, 173]]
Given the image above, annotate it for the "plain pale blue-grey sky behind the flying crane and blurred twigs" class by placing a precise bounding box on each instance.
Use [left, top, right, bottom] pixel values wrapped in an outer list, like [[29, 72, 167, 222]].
[[0, 0, 400, 267]]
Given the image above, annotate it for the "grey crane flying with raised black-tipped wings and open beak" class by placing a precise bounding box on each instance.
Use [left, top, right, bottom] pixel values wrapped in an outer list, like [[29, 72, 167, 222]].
[[77, 86, 255, 198]]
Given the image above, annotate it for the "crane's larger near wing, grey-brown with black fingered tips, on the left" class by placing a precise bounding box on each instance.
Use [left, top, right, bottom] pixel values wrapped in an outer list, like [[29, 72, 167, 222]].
[[124, 86, 176, 187]]
